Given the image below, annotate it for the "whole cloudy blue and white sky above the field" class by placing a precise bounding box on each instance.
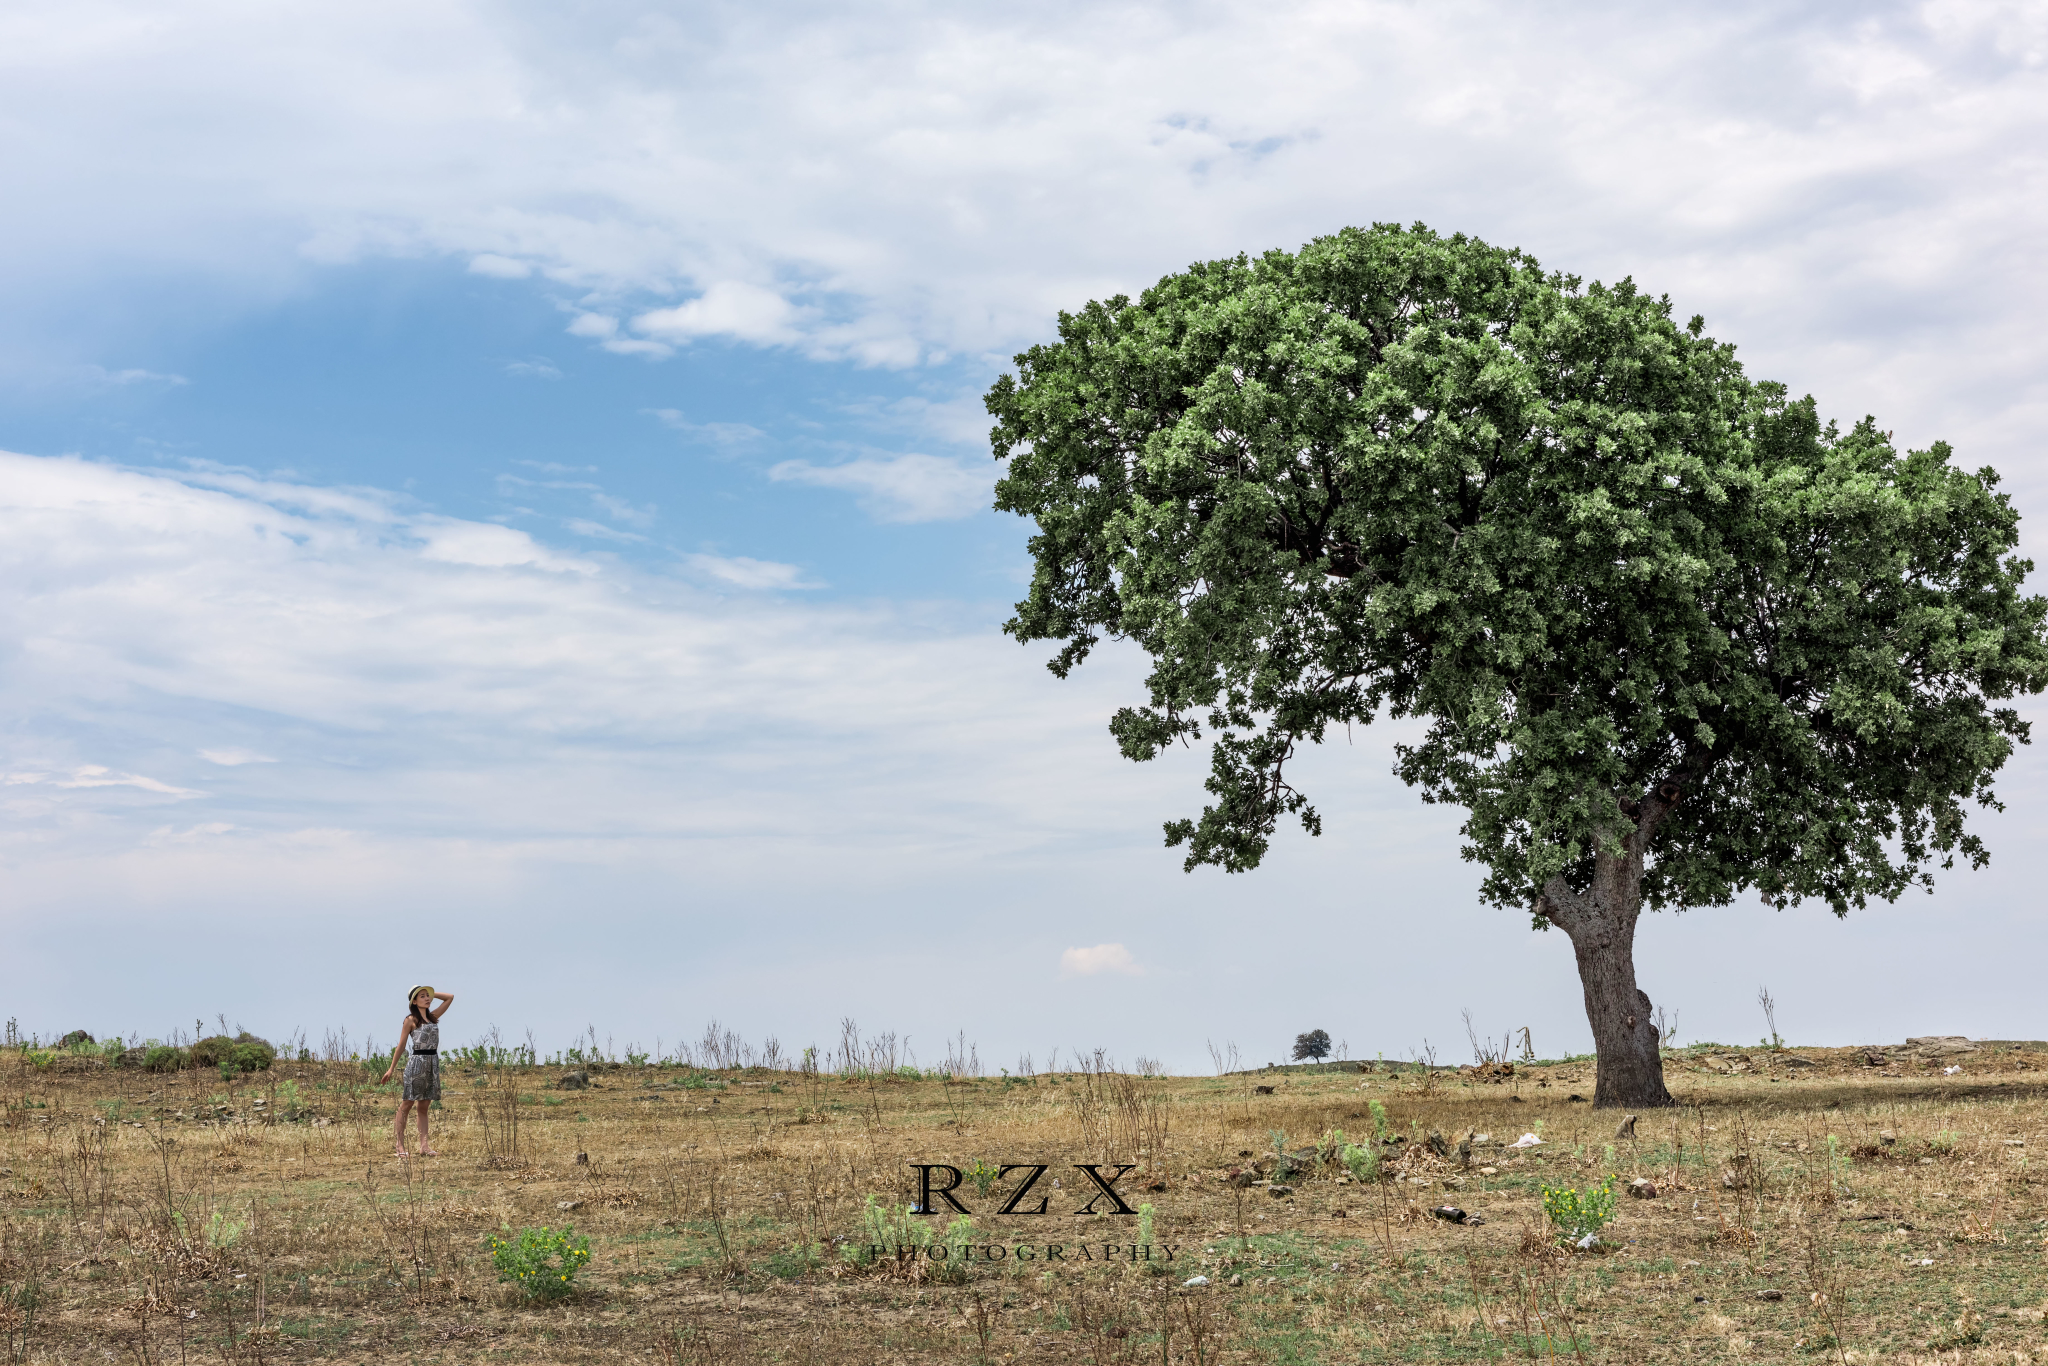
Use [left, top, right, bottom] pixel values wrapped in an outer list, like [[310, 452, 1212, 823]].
[[0, 0, 2048, 1067]]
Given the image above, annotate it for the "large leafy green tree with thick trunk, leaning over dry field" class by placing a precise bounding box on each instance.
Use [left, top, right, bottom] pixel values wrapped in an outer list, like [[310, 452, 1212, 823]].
[[987, 225, 2048, 1106]]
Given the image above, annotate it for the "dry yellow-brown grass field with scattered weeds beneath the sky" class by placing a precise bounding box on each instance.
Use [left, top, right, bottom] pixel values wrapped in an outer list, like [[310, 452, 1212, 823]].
[[0, 1047, 2048, 1364]]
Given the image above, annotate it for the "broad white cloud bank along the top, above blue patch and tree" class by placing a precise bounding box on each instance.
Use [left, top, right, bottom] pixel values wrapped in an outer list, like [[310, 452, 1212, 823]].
[[0, 0, 2048, 459]]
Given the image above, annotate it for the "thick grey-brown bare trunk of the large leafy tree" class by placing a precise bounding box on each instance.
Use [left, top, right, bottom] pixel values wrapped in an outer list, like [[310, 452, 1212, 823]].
[[1538, 854, 1675, 1110]]
